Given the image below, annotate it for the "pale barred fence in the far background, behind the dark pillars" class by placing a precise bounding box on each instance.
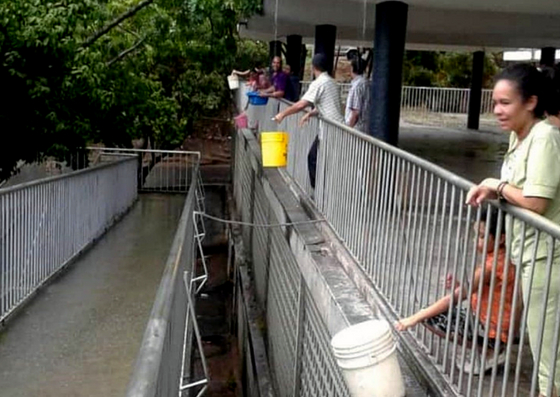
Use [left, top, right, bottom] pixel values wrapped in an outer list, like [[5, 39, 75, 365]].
[[301, 81, 495, 127]]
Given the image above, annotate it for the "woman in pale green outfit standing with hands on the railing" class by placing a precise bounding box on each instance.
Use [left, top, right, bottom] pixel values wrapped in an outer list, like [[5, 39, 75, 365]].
[[467, 64, 560, 396]]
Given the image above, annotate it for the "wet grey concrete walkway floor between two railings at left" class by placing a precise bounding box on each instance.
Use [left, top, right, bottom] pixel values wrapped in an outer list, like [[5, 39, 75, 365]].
[[0, 195, 184, 397]]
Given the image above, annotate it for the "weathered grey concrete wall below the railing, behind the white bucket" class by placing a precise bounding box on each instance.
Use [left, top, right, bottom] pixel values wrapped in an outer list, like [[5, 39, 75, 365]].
[[233, 130, 436, 396]]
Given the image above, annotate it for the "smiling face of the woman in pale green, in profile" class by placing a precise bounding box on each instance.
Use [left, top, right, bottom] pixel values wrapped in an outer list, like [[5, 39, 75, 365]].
[[492, 80, 537, 132]]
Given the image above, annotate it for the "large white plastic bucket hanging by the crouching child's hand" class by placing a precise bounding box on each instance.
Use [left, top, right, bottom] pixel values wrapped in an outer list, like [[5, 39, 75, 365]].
[[331, 320, 405, 397]]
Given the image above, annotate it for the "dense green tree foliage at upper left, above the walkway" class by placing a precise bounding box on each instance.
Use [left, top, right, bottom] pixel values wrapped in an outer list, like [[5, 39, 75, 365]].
[[0, 0, 267, 180]]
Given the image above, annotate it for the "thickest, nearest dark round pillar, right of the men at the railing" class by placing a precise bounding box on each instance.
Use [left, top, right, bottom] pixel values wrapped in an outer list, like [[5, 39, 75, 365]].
[[370, 1, 408, 145]]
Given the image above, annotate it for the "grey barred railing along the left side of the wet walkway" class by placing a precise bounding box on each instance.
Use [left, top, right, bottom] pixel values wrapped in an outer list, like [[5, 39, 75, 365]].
[[0, 157, 137, 321]]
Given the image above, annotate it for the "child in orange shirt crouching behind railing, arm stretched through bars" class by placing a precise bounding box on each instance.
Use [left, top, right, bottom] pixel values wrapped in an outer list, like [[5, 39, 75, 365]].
[[395, 211, 520, 373]]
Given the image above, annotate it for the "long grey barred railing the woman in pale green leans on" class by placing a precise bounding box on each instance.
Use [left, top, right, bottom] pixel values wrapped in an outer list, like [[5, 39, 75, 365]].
[[246, 96, 560, 397]]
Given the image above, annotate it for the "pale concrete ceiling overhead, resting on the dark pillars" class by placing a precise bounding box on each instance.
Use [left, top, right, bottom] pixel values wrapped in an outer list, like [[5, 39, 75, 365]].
[[241, 0, 560, 50]]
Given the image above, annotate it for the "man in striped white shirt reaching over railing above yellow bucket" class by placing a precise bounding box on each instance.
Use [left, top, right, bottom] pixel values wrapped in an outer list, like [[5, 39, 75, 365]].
[[274, 54, 344, 188]]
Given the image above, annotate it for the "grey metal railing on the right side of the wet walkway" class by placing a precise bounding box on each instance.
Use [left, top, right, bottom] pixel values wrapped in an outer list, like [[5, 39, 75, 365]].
[[126, 164, 208, 397]]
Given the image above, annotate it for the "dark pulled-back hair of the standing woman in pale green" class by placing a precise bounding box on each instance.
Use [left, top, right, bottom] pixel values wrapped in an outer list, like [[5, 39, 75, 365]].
[[495, 63, 551, 117]]
